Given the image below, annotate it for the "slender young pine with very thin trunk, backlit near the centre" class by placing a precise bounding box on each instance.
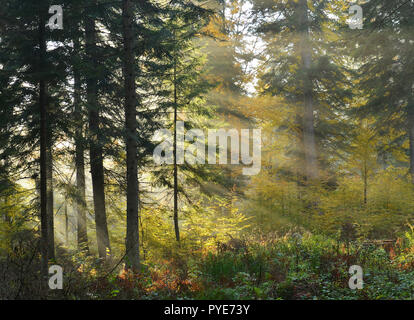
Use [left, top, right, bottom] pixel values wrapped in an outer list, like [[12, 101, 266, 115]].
[[150, 1, 211, 242]]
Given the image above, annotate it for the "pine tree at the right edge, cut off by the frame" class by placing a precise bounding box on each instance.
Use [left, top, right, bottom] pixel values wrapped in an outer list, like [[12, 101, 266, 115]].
[[349, 0, 414, 183]]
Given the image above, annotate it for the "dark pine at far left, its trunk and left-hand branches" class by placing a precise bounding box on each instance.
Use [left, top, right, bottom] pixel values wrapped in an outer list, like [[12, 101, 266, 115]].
[[0, 1, 62, 275]]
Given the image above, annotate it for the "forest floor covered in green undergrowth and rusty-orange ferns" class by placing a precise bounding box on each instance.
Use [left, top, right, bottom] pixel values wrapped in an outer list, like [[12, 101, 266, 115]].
[[2, 233, 414, 300]]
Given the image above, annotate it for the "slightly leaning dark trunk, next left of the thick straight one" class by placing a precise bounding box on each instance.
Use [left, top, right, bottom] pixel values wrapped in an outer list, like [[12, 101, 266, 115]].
[[85, 0, 110, 258]]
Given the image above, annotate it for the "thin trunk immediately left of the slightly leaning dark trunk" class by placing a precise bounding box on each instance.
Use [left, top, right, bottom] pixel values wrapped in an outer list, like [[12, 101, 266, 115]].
[[73, 36, 89, 251]]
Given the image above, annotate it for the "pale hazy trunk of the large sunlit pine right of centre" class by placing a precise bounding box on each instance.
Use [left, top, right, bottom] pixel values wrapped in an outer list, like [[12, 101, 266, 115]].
[[298, 0, 318, 181]]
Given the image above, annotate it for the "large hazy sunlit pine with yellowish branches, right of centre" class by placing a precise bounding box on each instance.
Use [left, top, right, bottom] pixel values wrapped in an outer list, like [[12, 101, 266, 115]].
[[253, 0, 351, 182]]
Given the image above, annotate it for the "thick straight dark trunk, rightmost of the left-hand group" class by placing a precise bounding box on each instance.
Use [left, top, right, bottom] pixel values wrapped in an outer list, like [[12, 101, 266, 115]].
[[122, 0, 140, 271]]
